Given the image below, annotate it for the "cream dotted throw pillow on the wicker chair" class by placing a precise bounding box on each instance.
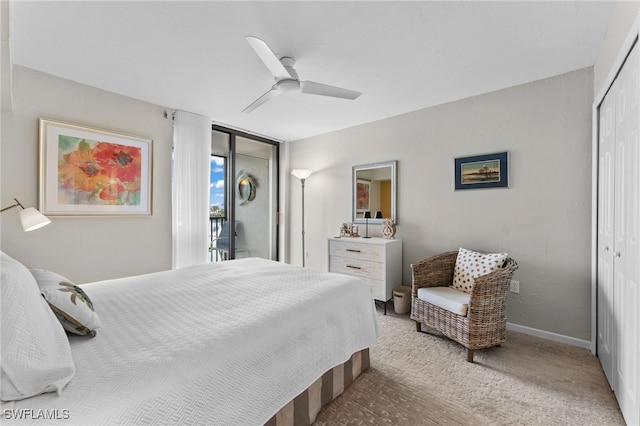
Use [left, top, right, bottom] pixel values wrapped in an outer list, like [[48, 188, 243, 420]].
[[451, 248, 509, 293]]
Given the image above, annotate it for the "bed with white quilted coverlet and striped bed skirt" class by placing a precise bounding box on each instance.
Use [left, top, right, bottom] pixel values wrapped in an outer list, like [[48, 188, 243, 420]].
[[2, 254, 378, 426]]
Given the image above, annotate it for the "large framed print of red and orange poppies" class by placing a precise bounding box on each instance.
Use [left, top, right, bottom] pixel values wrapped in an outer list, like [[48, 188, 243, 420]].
[[39, 118, 153, 216]]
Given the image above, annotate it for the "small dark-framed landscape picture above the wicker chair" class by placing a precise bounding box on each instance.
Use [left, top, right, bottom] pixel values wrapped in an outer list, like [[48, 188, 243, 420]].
[[454, 151, 509, 191]]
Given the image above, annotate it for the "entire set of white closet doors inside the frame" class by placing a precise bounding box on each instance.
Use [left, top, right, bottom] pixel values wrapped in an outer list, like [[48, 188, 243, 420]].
[[597, 42, 640, 424]]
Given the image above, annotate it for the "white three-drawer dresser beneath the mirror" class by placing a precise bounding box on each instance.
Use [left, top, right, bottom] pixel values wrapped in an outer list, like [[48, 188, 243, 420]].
[[329, 237, 402, 313]]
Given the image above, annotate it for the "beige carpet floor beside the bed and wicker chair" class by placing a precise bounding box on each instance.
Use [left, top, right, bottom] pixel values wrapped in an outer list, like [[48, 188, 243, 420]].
[[314, 308, 624, 426]]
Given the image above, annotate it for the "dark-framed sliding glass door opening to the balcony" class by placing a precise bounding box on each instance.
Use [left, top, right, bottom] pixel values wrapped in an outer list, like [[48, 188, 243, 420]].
[[209, 126, 279, 262]]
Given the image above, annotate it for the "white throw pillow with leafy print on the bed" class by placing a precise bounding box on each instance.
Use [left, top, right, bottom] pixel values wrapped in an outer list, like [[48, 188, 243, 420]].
[[30, 269, 100, 337]]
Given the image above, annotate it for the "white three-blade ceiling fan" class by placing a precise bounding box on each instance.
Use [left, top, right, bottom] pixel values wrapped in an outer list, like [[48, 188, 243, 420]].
[[242, 36, 362, 113]]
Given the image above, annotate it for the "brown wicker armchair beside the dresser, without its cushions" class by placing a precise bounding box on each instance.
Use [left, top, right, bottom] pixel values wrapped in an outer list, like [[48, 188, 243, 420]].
[[411, 251, 518, 362]]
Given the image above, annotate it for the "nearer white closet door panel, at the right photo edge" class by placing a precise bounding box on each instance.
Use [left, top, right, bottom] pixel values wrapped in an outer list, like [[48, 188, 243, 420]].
[[613, 43, 640, 424]]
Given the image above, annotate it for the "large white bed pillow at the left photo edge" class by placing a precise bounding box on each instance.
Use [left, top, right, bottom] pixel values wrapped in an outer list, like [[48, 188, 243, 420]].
[[0, 252, 75, 401]]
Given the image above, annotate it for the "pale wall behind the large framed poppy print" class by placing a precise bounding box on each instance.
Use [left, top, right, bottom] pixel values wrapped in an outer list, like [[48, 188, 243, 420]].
[[0, 67, 173, 283]]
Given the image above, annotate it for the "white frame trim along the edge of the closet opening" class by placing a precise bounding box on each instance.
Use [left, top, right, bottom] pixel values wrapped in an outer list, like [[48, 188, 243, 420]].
[[590, 13, 640, 355]]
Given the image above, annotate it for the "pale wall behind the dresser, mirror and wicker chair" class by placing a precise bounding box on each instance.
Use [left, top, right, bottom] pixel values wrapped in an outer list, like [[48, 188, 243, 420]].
[[287, 68, 593, 340]]
